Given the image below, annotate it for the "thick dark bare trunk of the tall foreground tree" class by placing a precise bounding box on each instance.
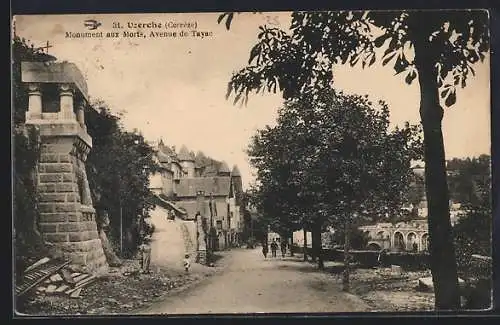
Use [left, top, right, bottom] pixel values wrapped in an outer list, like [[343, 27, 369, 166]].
[[414, 33, 460, 310]]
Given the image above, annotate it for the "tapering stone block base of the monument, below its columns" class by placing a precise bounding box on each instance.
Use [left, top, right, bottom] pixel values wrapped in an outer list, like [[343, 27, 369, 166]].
[[37, 136, 107, 274]]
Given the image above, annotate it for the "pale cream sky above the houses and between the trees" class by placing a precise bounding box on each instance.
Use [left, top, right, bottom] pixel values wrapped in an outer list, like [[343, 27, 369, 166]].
[[15, 12, 490, 187]]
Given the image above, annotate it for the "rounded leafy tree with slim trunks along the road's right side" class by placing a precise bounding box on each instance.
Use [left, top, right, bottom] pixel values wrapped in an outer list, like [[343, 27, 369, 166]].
[[248, 89, 421, 290]]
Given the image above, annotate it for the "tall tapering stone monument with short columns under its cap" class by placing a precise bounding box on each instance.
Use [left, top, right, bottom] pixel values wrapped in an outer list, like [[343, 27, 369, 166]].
[[21, 62, 108, 274]]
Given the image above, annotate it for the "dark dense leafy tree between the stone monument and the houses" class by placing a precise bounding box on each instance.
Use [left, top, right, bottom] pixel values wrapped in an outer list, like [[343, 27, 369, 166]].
[[86, 101, 158, 260]]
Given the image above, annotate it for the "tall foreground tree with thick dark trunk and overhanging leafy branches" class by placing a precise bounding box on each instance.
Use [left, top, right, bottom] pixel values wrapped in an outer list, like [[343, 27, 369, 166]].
[[219, 10, 489, 309]]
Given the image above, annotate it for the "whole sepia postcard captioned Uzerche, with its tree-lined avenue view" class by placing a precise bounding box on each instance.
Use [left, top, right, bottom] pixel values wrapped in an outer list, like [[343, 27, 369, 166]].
[[11, 9, 493, 318]]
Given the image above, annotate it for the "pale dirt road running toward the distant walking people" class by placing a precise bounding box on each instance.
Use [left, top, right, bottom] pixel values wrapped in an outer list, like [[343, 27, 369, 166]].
[[142, 249, 368, 314]]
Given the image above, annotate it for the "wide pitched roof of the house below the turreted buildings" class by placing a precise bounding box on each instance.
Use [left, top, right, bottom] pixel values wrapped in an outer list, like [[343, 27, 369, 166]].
[[176, 176, 231, 197]]
